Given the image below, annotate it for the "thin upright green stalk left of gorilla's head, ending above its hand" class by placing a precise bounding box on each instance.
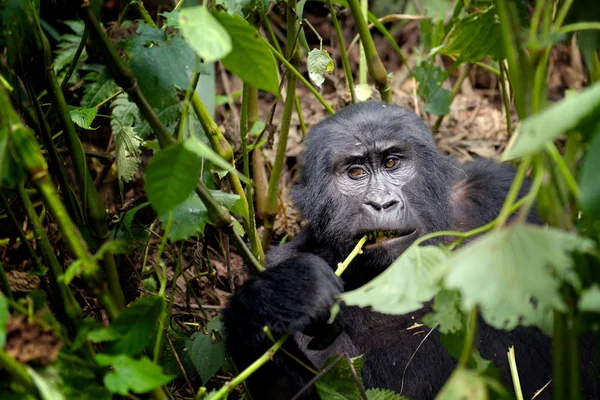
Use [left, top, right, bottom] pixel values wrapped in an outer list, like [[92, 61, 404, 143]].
[[240, 83, 265, 264]]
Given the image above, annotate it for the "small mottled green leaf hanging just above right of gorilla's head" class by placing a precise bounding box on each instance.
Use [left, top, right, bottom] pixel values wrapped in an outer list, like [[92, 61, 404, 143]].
[[414, 61, 452, 115]]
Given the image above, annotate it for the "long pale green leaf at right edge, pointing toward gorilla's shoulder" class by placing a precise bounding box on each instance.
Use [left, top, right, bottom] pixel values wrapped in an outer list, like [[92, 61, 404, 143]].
[[502, 82, 600, 160]]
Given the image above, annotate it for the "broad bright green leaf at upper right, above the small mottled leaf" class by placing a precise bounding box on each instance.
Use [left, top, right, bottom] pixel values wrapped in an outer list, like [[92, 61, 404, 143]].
[[440, 7, 504, 62]]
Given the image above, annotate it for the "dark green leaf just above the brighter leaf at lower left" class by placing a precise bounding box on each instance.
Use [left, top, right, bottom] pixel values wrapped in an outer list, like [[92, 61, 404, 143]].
[[103, 296, 165, 355]]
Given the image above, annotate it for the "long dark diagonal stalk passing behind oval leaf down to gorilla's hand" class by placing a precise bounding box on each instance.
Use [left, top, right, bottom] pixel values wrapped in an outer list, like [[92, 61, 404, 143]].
[[80, 2, 264, 271]]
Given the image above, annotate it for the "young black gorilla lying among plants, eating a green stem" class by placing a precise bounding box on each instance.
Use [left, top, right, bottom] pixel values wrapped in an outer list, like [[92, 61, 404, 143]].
[[224, 102, 600, 400]]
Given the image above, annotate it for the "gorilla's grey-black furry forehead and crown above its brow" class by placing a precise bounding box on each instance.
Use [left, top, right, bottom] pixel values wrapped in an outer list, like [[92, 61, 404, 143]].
[[305, 101, 433, 157]]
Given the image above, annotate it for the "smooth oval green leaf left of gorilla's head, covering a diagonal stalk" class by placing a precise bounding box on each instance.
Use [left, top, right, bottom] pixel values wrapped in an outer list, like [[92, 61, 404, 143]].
[[145, 139, 202, 215]]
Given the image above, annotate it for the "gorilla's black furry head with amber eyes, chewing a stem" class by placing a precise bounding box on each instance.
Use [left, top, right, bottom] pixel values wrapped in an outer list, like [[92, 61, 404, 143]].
[[294, 102, 454, 280]]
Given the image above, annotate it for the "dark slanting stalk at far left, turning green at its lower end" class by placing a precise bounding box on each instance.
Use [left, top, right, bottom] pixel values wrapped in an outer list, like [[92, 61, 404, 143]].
[[18, 185, 81, 324]]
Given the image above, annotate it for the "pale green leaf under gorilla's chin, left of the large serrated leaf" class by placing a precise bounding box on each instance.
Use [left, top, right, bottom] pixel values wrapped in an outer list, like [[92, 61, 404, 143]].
[[339, 246, 446, 314]]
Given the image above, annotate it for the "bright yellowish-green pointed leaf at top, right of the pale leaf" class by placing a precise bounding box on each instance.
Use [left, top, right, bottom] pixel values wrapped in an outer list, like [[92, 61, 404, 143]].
[[215, 12, 279, 95]]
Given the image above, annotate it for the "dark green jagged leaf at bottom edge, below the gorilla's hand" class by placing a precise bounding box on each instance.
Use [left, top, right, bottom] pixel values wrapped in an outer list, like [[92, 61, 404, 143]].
[[315, 355, 363, 400]]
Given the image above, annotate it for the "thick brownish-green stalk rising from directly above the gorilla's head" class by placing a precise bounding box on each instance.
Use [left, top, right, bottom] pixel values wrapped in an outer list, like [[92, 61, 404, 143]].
[[348, 0, 392, 103]]
